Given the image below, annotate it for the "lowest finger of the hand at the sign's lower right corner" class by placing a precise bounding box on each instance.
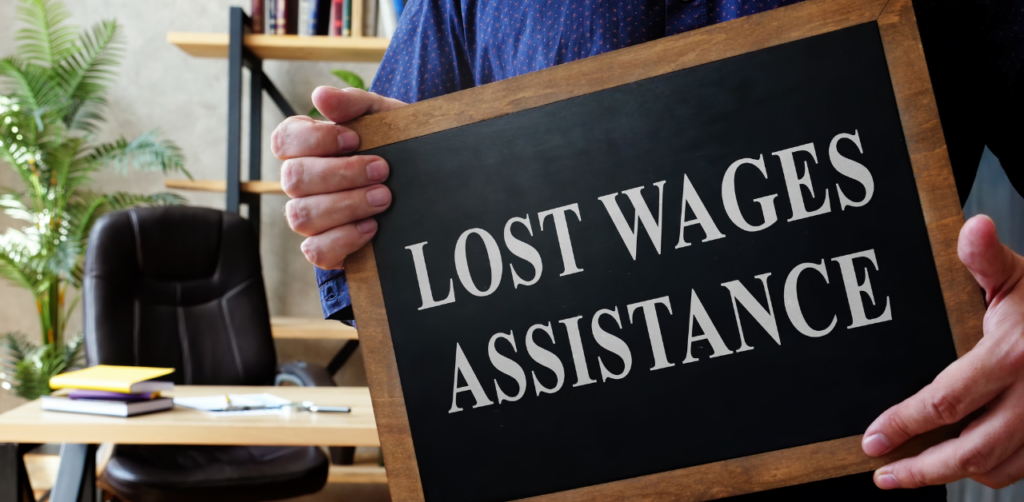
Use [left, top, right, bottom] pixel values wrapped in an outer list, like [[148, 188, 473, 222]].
[[874, 384, 1024, 489]]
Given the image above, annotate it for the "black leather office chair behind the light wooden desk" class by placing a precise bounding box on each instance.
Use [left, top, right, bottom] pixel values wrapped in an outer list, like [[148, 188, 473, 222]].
[[83, 207, 334, 502]]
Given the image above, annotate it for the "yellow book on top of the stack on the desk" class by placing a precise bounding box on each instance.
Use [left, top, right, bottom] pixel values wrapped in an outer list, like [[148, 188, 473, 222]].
[[50, 365, 174, 393]]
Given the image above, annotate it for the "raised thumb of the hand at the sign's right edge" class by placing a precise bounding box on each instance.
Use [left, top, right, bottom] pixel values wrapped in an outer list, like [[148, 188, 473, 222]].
[[956, 214, 1024, 303]]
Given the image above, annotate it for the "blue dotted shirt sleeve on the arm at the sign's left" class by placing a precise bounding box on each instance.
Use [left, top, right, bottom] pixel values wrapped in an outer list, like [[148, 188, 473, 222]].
[[316, 0, 473, 324]]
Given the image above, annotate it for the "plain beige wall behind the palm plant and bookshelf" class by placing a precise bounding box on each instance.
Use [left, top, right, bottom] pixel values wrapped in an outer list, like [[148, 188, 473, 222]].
[[0, 0, 377, 372]]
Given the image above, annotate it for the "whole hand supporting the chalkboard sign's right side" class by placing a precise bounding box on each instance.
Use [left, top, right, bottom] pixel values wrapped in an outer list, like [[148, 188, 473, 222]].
[[862, 216, 1024, 490]]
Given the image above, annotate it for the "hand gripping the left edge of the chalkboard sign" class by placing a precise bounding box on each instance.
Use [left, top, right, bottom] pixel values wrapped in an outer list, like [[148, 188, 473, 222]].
[[270, 87, 406, 269]]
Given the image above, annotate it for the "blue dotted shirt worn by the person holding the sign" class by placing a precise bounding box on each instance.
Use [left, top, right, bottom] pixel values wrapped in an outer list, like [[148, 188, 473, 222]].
[[316, 0, 1024, 321]]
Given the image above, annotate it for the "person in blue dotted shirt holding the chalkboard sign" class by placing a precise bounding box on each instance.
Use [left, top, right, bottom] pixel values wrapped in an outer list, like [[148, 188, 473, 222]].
[[271, 0, 1024, 500]]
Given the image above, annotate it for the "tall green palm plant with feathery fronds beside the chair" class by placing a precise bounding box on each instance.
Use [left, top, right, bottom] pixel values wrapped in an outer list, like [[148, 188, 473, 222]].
[[0, 0, 191, 399]]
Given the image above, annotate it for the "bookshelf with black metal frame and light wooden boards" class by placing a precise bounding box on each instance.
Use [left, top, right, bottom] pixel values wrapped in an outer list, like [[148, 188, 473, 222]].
[[165, 7, 382, 383]]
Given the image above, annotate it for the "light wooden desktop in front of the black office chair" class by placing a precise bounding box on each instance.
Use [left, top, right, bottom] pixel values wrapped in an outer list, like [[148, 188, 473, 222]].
[[0, 385, 380, 447]]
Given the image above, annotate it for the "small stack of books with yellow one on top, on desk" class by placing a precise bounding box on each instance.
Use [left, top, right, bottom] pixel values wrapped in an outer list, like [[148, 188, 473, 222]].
[[42, 365, 174, 417]]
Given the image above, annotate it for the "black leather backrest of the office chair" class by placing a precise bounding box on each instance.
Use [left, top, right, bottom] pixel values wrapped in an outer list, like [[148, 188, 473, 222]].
[[83, 206, 276, 385]]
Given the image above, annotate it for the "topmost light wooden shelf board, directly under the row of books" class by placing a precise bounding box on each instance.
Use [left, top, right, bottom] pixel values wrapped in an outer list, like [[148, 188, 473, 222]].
[[167, 32, 391, 62]]
